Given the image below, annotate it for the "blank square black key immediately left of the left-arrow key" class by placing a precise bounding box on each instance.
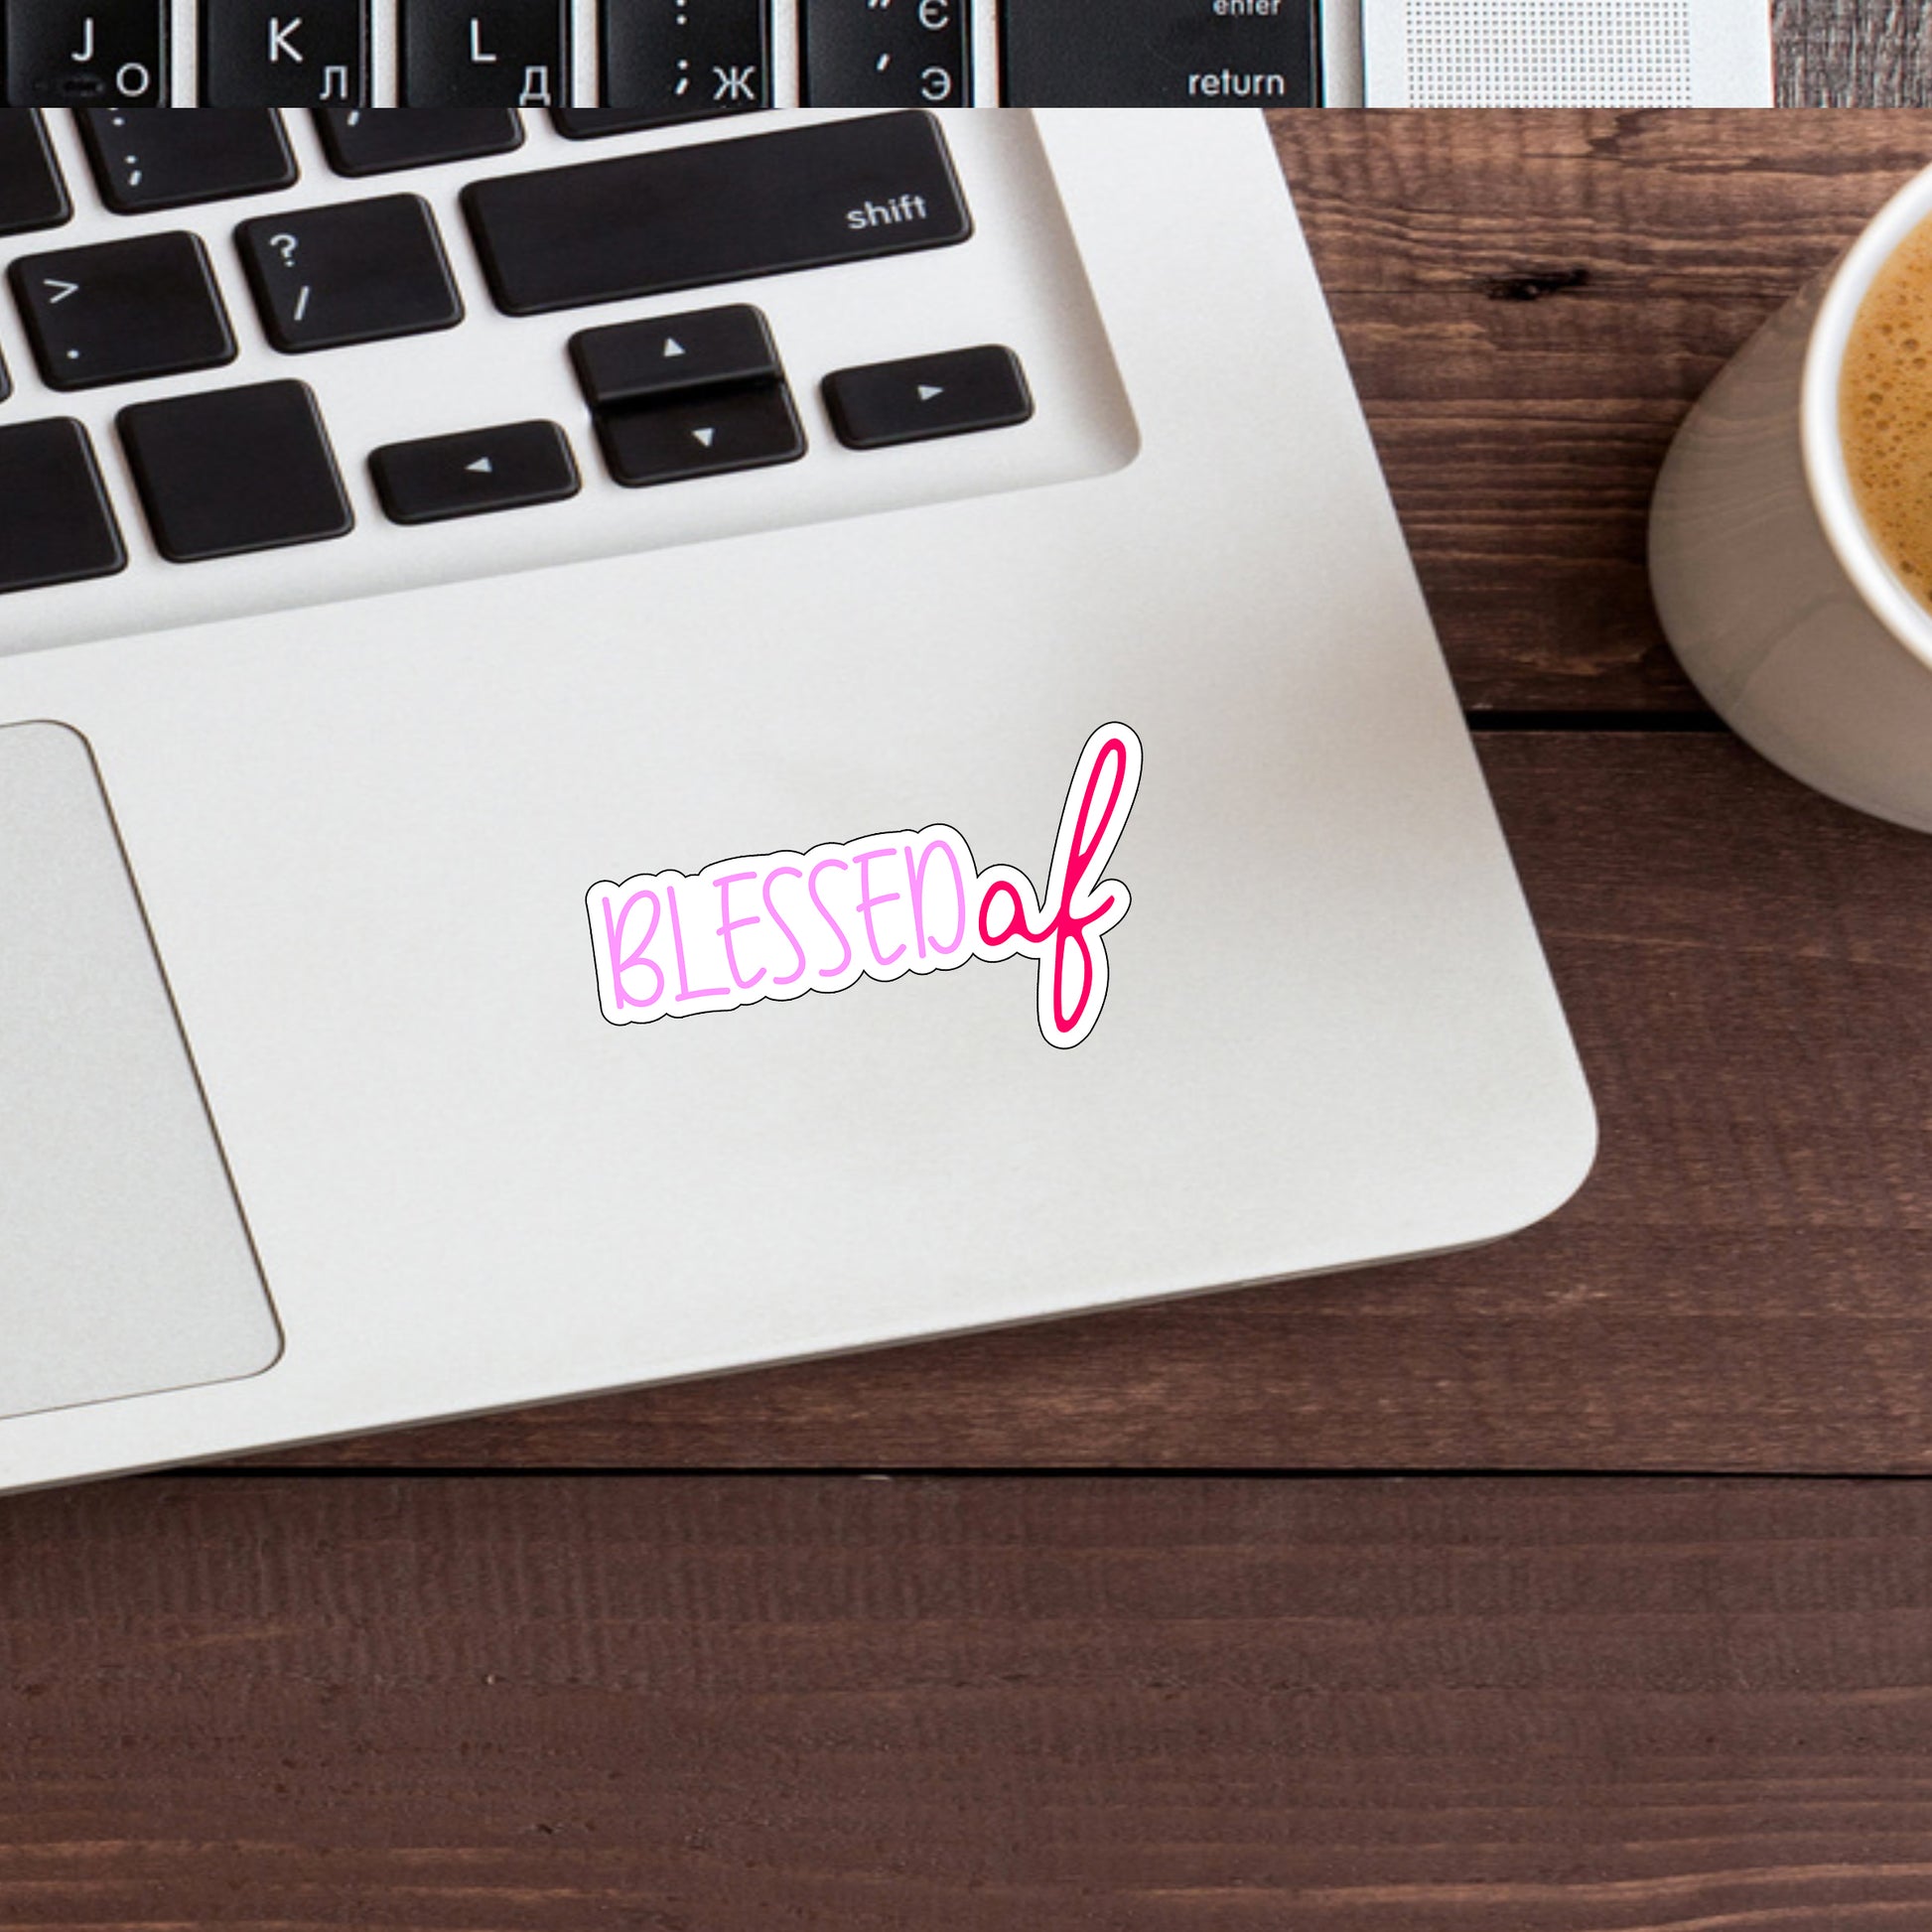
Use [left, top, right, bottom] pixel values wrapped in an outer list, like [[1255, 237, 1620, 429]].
[[118, 382, 355, 564]]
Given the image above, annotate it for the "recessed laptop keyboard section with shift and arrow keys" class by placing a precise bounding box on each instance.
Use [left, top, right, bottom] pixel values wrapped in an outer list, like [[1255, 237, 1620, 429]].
[[0, 108, 1134, 649]]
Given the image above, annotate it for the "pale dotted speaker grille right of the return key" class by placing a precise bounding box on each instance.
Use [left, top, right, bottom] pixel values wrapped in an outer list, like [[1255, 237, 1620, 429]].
[[1407, 0, 1693, 108]]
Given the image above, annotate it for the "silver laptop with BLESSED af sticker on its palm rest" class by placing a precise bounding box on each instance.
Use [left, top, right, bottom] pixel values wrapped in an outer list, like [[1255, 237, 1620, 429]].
[[0, 110, 1592, 1485]]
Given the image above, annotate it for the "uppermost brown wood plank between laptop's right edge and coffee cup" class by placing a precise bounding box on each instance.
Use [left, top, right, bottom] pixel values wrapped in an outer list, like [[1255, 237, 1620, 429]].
[[1273, 112, 1932, 711]]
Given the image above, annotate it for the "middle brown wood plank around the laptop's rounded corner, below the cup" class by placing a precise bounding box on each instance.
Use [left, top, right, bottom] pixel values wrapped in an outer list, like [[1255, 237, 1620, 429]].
[[260, 733, 1932, 1467]]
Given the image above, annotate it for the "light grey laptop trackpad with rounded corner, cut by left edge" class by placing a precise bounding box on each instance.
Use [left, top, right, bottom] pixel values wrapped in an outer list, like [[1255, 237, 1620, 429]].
[[0, 725, 280, 1416]]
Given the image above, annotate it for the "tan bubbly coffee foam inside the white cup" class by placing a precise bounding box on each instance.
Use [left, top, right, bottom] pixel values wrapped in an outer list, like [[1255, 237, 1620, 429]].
[[1838, 222, 1932, 609]]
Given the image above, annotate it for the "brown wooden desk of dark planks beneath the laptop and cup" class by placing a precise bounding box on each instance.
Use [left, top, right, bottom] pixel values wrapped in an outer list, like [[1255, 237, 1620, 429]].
[[11, 101, 1932, 1932]]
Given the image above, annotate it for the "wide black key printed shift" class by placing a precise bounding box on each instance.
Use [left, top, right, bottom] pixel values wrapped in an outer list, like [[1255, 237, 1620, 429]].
[[464, 114, 972, 315]]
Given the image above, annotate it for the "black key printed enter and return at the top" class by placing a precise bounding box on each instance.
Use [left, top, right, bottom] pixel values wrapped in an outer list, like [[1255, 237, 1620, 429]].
[[999, 0, 1321, 108]]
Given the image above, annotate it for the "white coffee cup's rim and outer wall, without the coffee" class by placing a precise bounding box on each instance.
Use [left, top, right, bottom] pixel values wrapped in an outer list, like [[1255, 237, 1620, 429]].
[[1650, 156, 1932, 831]]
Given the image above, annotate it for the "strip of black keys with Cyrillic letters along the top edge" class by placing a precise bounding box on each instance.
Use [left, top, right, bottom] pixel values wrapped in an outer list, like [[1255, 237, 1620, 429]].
[[0, 0, 1346, 110]]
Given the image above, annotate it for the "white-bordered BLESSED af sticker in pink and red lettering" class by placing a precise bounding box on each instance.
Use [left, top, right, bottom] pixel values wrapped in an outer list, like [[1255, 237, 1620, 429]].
[[584, 725, 1140, 1047]]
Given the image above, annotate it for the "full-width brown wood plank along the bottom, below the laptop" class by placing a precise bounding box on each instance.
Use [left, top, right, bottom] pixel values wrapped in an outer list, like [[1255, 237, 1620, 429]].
[[0, 1478, 1932, 1932]]
